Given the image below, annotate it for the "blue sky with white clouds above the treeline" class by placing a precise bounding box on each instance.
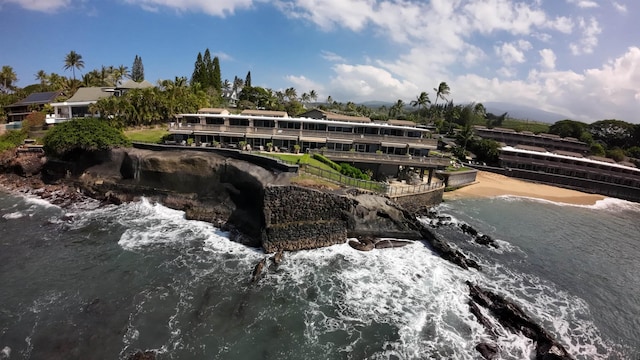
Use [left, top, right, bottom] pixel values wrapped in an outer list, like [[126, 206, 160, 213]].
[[0, 0, 640, 123]]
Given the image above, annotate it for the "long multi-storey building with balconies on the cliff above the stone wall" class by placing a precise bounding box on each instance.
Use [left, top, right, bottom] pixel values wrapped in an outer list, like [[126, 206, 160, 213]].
[[169, 109, 437, 156]]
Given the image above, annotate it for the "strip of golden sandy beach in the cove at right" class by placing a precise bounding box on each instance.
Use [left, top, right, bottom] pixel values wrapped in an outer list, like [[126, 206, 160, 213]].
[[444, 171, 605, 205]]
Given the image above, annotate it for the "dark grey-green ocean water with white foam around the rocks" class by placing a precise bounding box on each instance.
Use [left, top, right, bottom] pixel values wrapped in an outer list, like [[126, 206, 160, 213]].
[[0, 193, 640, 359]]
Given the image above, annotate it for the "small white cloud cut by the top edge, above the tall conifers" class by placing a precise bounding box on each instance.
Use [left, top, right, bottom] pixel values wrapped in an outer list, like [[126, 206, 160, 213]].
[[125, 0, 253, 17]]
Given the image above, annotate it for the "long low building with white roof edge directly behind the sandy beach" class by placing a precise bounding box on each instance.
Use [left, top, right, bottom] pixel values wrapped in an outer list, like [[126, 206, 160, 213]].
[[500, 145, 640, 189]]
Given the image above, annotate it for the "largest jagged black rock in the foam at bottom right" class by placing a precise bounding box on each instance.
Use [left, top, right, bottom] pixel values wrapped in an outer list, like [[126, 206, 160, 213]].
[[467, 281, 573, 360]]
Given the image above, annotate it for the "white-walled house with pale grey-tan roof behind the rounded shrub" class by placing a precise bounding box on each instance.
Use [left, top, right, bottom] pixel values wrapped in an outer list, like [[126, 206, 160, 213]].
[[45, 87, 113, 125]]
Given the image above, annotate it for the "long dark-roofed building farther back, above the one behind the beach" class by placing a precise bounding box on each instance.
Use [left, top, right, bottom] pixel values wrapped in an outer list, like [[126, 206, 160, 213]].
[[474, 126, 589, 155]]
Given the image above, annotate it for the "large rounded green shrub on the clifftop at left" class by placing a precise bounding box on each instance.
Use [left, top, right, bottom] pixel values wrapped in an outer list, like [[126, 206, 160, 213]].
[[43, 118, 130, 157]]
